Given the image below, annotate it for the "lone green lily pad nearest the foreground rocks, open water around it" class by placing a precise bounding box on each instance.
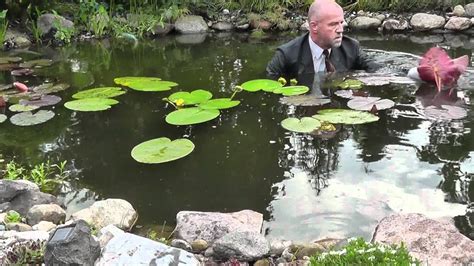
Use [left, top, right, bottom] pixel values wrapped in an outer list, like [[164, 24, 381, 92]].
[[131, 138, 194, 164]]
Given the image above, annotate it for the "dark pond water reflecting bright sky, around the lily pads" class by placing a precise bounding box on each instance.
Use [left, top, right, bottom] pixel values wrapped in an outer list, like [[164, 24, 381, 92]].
[[0, 31, 474, 240]]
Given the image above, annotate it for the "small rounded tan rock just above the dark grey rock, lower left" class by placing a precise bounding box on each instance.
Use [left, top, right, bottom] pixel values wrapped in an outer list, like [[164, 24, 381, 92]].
[[26, 204, 66, 225]]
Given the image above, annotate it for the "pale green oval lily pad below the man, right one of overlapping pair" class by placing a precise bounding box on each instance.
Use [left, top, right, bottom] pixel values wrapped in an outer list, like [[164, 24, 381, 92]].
[[313, 109, 379, 125]]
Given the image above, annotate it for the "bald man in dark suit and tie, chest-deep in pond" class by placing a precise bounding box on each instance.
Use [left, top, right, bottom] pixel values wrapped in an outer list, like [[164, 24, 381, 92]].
[[266, 0, 379, 79]]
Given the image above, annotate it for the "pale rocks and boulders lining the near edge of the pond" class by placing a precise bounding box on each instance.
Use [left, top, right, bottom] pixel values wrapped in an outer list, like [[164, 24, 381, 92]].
[[0, 180, 474, 265]]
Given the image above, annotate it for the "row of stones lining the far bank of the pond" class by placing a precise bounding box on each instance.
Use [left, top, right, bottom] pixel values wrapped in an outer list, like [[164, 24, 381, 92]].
[[3, 3, 474, 49]]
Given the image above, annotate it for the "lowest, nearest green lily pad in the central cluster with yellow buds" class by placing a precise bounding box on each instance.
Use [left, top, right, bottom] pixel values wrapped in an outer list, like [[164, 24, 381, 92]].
[[166, 107, 220, 126]]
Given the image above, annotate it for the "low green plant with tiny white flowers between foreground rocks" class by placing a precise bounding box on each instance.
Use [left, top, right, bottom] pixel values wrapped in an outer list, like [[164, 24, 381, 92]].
[[310, 238, 420, 266]]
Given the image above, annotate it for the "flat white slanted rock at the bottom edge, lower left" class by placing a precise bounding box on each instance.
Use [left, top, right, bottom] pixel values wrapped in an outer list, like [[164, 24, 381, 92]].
[[95, 228, 199, 266]]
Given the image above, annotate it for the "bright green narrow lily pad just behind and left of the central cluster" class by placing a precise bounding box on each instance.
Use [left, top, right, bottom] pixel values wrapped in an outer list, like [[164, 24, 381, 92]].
[[114, 77, 178, 91]]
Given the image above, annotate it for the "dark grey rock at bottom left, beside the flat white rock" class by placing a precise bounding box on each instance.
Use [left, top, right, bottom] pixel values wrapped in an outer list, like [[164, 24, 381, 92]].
[[44, 220, 100, 265]]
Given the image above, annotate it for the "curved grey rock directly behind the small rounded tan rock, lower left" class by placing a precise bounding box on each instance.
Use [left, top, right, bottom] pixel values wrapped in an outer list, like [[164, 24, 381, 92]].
[[0, 190, 59, 217]]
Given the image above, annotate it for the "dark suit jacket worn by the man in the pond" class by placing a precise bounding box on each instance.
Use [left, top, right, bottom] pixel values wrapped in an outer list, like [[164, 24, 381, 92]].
[[267, 33, 380, 79]]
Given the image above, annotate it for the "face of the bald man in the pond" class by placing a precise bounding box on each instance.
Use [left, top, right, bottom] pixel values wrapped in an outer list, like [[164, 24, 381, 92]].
[[309, 6, 344, 49]]
